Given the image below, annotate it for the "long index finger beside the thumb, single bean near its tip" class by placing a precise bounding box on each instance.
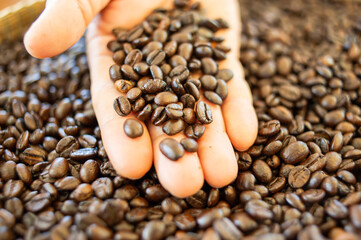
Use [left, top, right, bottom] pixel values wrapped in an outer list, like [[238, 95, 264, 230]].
[[87, 24, 153, 179]]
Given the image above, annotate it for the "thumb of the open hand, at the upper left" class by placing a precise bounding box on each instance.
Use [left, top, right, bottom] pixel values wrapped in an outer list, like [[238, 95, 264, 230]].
[[24, 0, 110, 58]]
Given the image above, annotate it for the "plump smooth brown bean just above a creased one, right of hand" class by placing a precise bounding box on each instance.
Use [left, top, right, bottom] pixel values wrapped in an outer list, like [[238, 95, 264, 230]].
[[281, 141, 309, 164]]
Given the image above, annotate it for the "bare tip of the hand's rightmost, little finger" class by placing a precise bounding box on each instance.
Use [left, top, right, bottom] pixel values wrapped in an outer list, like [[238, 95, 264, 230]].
[[222, 98, 258, 151]]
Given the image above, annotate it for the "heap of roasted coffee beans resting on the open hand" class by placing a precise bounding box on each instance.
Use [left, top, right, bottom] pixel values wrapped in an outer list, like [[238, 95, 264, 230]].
[[108, 1, 233, 160]]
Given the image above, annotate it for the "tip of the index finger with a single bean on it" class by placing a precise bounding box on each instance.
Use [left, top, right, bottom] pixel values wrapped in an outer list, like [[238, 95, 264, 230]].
[[101, 118, 153, 179]]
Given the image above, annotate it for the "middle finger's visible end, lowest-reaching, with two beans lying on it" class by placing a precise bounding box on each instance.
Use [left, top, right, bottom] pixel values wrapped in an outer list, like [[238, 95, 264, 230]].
[[149, 123, 204, 198]]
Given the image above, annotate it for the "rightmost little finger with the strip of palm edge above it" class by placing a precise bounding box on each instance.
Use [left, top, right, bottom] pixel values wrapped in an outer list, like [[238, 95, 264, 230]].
[[201, 0, 258, 151]]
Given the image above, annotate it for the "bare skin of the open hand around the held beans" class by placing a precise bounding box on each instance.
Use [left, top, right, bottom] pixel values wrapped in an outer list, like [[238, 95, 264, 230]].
[[24, 0, 258, 197]]
